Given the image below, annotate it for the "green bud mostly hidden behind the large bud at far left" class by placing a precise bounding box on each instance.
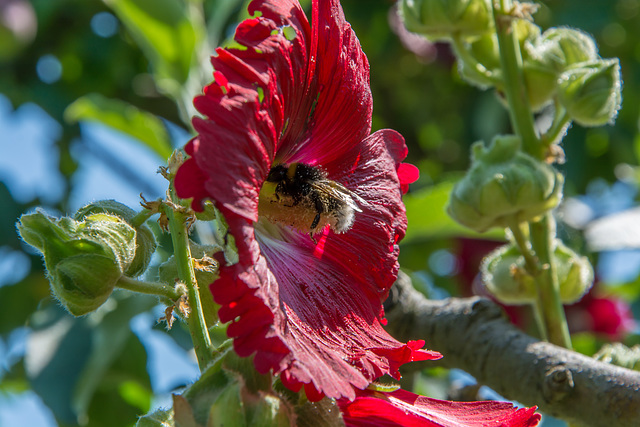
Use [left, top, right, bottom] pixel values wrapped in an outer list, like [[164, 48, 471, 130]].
[[75, 200, 157, 277]]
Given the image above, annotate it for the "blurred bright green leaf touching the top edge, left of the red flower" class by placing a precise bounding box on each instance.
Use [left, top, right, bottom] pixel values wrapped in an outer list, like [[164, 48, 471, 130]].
[[104, 0, 201, 94]]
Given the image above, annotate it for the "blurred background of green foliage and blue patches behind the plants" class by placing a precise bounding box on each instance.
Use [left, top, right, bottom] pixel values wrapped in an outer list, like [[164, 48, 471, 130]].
[[0, 0, 640, 427]]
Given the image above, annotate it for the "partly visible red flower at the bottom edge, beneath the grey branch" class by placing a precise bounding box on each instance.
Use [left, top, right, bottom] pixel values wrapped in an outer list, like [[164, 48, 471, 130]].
[[338, 389, 541, 427]]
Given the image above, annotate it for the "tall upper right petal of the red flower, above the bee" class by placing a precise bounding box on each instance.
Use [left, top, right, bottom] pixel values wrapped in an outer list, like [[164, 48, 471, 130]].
[[278, 0, 373, 164]]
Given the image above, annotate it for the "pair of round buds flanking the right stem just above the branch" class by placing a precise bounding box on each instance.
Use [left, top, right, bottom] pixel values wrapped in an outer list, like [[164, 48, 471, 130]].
[[480, 240, 593, 305]]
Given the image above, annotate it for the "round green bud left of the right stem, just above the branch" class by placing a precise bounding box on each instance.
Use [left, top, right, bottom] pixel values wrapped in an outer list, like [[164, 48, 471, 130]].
[[480, 244, 537, 305]]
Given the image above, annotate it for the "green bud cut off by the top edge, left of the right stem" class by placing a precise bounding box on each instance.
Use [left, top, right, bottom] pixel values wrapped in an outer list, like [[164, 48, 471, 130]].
[[400, 0, 493, 40]]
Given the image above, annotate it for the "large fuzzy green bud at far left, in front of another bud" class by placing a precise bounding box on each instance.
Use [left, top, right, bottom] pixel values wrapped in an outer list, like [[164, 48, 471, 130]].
[[17, 211, 136, 316]]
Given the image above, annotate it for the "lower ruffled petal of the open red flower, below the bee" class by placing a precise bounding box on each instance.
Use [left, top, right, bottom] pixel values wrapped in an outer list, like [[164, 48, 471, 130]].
[[216, 217, 439, 398]]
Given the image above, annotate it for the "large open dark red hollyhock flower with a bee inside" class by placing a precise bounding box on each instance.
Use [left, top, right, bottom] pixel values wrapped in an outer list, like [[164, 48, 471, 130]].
[[175, 0, 440, 400]]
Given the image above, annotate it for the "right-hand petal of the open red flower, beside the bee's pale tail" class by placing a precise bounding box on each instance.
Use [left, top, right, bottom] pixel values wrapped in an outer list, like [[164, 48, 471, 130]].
[[322, 130, 416, 302]]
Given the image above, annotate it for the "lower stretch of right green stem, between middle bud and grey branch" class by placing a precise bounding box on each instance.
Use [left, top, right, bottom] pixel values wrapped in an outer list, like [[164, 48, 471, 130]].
[[530, 213, 571, 349]]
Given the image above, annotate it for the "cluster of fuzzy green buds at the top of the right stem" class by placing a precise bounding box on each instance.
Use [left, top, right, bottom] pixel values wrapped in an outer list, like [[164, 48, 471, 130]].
[[401, 0, 622, 126]]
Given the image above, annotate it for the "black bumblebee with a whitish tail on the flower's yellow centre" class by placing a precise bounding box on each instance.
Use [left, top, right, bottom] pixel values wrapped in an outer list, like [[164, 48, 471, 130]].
[[265, 163, 366, 237]]
